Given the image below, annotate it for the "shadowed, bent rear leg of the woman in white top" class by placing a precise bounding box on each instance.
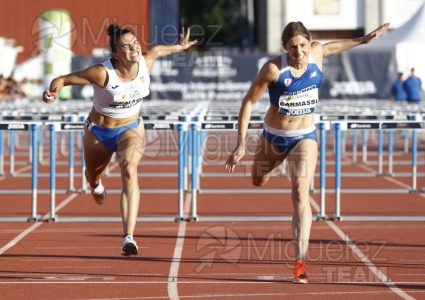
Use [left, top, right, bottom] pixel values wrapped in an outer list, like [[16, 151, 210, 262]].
[[84, 127, 113, 188]]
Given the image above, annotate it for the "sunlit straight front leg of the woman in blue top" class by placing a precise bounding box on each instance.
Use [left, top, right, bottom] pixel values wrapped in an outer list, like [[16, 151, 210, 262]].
[[287, 139, 318, 260]]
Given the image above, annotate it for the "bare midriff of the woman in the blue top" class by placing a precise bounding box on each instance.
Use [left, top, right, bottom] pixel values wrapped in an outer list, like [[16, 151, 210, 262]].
[[264, 105, 314, 130]]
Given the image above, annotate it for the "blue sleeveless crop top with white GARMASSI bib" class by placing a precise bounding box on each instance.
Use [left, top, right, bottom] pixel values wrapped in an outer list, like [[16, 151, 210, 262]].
[[269, 53, 323, 116]]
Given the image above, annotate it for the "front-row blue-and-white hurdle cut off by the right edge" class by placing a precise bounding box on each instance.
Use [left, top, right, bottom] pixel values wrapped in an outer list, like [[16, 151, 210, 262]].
[[332, 121, 425, 221]]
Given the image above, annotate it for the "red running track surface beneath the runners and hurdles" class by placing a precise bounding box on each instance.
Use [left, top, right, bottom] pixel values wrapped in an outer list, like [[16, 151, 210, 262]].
[[0, 130, 425, 300]]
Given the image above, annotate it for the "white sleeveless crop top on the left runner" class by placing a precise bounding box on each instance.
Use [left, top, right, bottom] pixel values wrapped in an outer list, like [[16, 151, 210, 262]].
[[93, 57, 150, 118]]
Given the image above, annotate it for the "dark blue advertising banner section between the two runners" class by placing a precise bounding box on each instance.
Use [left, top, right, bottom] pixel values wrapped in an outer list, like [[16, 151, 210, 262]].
[[149, 51, 269, 101]]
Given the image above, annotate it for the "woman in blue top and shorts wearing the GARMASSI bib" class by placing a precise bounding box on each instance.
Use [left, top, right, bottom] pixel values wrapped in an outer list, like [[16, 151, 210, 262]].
[[225, 22, 389, 283]]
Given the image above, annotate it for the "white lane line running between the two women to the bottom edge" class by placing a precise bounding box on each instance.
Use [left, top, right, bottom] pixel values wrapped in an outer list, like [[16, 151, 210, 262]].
[[167, 194, 191, 300]]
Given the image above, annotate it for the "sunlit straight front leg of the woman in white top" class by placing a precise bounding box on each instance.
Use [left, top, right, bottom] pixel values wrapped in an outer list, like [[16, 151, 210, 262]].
[[116, 120, 146, 235]]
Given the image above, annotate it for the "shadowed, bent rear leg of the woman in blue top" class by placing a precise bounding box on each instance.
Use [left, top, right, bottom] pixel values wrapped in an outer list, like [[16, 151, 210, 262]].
[[251, 135, 286, 186]]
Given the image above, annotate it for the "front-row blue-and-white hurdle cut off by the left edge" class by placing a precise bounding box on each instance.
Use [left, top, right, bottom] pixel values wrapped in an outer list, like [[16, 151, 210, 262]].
[[0, 122, 41, 222]]
